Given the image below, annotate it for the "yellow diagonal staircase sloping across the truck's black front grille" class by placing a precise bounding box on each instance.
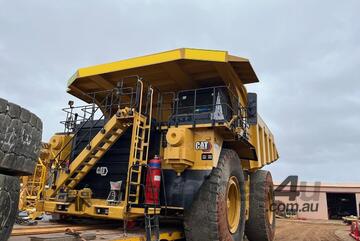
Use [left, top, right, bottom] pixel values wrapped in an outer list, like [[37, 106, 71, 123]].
[[48, 110, 132, 197]]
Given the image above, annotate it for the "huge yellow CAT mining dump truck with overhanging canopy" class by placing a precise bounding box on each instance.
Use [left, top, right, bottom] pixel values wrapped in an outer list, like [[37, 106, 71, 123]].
[[25, 49, 278, 241]]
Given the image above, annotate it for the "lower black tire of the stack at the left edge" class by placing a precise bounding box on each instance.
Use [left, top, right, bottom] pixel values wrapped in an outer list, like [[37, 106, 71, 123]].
[[0, 174, 20, 241]]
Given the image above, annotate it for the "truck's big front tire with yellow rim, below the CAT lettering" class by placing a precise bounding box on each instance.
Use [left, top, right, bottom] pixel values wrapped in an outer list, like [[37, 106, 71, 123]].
[[184, 149, 245, 241]]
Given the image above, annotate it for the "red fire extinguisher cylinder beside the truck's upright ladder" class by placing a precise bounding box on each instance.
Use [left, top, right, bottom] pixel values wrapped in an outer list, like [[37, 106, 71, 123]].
[[145, 155, 161, 205]]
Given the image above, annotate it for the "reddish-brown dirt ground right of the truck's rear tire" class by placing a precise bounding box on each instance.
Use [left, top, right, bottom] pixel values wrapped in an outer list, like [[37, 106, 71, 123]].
[[275, 219, 354, 241]]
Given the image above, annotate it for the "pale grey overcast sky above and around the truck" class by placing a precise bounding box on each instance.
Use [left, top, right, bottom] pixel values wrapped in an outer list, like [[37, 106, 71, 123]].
[[0, 0, 360, 183]]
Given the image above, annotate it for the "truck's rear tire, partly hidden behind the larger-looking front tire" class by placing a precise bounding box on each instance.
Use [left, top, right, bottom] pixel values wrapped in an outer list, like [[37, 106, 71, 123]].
[[245, 170, 275, 241]]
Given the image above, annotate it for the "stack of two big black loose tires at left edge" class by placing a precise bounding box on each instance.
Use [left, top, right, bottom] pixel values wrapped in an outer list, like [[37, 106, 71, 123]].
[[0, 98, 42, 241]]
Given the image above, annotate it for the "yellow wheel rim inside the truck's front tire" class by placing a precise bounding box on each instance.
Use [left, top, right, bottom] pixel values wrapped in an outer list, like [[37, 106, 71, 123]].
[[226, 176, 241, 233]]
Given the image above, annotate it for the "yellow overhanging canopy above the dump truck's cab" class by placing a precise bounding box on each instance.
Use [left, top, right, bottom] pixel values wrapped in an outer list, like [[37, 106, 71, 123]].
[[68, 48, 258, 104]]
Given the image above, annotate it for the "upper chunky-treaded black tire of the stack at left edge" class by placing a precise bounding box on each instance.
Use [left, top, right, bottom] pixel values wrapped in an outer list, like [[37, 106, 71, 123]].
[[0, 98, 42, 176]]
